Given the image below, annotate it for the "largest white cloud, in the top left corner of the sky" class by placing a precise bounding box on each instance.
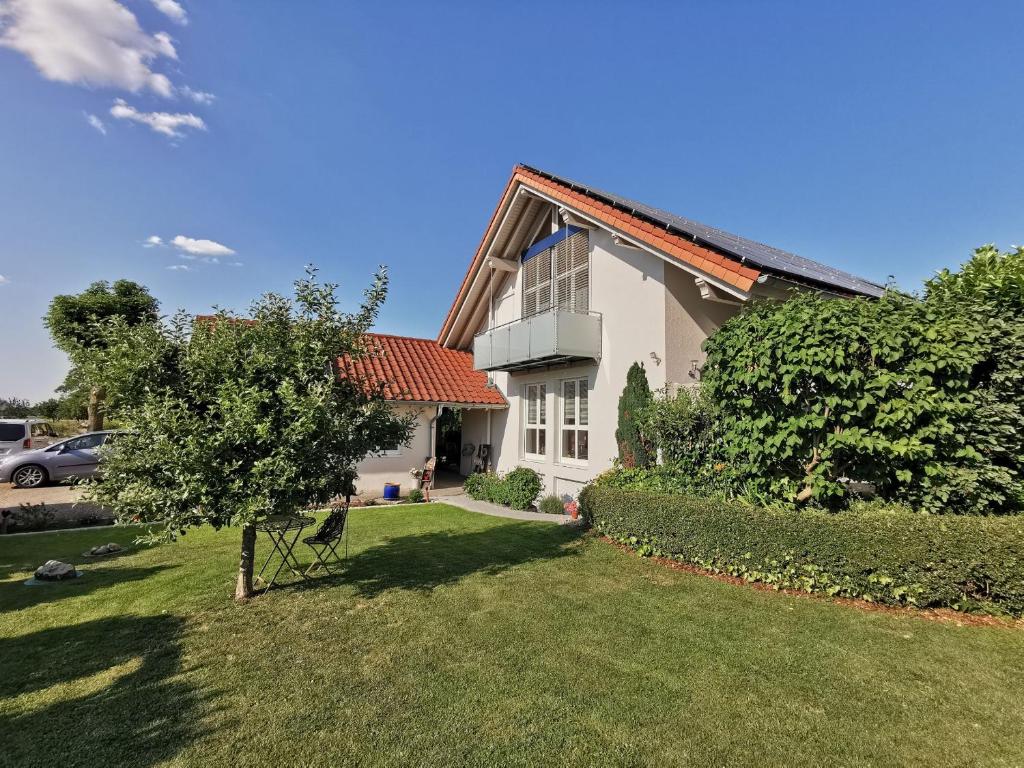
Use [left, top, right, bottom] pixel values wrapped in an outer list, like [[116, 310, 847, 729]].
[[0, 0, 177, 97]]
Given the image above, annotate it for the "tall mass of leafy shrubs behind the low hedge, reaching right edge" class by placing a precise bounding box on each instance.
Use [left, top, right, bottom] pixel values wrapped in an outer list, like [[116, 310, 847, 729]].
[[700, 246, 1024, 514]]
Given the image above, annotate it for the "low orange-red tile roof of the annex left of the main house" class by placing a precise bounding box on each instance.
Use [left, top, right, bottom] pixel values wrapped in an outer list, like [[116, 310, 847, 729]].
[[339, 334, 508, 407]]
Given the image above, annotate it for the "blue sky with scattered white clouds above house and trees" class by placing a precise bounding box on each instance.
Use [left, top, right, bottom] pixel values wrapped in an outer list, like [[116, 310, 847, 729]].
[[0, 0, 1024, 399]]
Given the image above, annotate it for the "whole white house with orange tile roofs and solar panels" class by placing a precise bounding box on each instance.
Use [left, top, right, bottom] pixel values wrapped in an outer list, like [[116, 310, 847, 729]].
[[359, 165, 883, 496]]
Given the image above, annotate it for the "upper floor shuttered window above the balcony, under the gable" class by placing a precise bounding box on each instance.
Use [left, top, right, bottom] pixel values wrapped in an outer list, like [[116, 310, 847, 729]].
[[522, 227, 590, 317]]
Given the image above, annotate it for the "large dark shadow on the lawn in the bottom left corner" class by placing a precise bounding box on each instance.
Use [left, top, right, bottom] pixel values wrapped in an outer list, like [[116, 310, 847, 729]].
[[0, 615, 202, 767]]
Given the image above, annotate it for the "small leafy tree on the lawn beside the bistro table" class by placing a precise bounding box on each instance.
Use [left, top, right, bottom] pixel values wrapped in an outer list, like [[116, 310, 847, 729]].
[[87, 269, 413, 599]]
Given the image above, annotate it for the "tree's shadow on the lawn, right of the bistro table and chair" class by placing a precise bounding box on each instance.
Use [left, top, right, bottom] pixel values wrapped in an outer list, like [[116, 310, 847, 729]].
[[311, 523, 582, 597]]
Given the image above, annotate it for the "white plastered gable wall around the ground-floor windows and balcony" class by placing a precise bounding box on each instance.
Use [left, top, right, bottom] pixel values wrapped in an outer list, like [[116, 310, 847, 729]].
[[473, 230, 673, 497]]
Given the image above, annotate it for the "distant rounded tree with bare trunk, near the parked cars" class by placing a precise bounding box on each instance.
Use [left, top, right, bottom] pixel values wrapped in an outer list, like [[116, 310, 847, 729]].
[[43, 280, 160, 430]]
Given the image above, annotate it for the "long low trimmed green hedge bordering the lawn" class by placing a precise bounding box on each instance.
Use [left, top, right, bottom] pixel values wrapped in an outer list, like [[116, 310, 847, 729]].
[[580, 485, 1024, 616]]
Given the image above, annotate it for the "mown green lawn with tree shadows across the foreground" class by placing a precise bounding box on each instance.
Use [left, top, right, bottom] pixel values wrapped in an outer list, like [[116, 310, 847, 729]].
[[0, 505, 1024, 768]]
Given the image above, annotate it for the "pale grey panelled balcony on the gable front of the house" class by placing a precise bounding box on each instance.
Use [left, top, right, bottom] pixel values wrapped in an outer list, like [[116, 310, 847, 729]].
[[473, 309, 601, 371]]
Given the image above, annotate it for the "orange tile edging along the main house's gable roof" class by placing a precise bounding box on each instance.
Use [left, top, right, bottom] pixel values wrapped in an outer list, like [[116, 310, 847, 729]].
[[437, 165, 761, 348]]
